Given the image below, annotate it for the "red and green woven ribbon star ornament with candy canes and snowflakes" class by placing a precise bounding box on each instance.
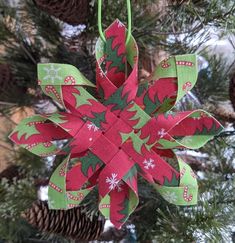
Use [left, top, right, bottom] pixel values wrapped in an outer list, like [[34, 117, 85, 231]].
[[10, 20, 222, 228]]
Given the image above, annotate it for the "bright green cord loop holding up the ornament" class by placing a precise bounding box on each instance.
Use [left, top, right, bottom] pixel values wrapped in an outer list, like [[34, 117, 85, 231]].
[[98, 0, 131, 45]]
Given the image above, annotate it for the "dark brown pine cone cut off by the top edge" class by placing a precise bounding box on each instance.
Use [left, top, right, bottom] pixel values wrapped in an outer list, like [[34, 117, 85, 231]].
[[34, 0, 89, 25]]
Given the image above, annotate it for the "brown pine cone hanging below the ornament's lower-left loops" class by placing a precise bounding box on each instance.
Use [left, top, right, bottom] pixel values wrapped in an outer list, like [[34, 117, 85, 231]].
[[22, 201, 105, 240]]
